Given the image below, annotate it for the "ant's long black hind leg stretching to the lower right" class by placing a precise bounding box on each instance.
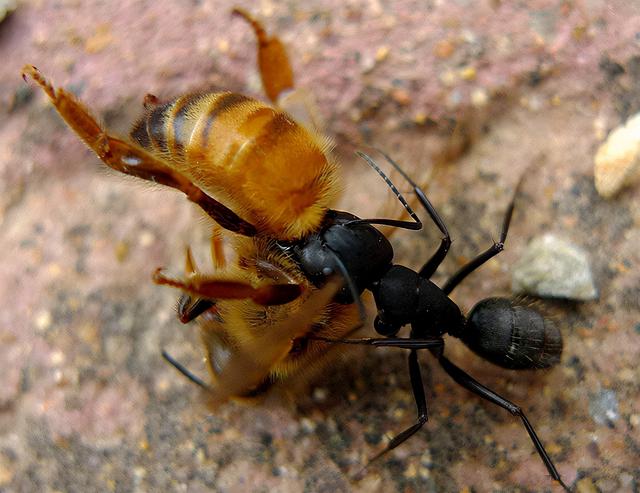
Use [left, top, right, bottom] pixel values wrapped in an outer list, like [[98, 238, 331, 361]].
[[436, 354, 570, 491]]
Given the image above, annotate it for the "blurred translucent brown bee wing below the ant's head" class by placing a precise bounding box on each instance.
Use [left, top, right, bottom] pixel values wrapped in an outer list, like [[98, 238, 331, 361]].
[[210, 279, 342, 406]]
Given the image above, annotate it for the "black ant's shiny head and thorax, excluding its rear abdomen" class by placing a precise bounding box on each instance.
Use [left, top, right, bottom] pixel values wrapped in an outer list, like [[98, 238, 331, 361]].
[[286, 210, 465, 337]]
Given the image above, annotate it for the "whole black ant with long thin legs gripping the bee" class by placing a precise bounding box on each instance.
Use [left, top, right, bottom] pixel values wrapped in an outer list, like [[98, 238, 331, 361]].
[[163, 152, 570, 491]]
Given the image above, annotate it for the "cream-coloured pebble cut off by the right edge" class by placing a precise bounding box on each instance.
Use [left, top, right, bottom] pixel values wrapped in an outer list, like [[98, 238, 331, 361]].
[[594, 113, 640, 199]]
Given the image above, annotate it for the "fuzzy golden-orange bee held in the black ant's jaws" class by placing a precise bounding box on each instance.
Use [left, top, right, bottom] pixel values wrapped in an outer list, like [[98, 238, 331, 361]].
[[23, 9, 357, 401]]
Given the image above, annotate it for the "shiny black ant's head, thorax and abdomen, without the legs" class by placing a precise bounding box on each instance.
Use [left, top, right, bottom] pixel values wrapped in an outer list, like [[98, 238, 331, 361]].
[[283, 210, 562, 369]]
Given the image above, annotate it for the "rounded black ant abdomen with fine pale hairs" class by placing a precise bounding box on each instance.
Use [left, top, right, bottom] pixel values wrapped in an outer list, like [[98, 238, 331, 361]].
[[459, 298, 562, 370]]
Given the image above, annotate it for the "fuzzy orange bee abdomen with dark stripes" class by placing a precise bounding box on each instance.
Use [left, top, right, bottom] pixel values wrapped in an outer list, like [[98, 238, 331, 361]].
[[131, 92, 338, 239]]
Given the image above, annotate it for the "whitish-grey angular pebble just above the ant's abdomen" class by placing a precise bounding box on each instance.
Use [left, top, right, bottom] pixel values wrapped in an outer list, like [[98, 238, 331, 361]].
[[511, 234, 598, 301]]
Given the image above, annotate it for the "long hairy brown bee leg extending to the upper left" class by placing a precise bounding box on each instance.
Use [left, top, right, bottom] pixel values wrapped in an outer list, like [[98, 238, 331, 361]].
[[22, 65, 256, 236]]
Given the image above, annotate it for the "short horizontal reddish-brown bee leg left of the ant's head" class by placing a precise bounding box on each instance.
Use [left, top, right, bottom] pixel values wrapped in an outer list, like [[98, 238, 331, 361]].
[[153, 268, 302, 306]]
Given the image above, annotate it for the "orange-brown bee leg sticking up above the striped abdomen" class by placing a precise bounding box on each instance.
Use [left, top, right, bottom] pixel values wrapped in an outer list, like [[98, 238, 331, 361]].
[[231, 8, 293, 103]]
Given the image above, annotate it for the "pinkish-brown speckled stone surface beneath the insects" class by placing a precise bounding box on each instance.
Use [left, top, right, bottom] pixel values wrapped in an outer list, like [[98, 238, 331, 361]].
[[0, 0, 640, 493]]
